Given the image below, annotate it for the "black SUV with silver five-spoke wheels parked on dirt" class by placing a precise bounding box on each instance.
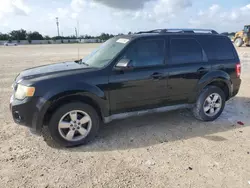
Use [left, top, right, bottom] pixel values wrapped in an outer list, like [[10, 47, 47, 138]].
[[10, 29, 241, 146]]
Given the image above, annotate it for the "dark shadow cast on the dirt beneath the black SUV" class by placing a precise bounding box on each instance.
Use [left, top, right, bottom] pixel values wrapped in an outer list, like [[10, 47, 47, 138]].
[[45, 97, 250, 152]]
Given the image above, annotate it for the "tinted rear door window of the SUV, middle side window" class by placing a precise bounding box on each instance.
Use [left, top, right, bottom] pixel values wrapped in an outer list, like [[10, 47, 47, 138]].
[[171, 39, 203, 64]]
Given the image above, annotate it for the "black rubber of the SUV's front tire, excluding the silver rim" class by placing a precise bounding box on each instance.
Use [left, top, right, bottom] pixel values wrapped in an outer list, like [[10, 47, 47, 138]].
[[49, 102, 100, 147]]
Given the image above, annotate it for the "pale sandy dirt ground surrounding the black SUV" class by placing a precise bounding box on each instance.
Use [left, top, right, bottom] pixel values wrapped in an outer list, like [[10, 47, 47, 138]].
[[0, 44, 250, 188]]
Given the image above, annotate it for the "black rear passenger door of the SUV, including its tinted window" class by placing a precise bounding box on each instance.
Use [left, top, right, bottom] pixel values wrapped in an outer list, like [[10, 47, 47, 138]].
[[167, 35, 211, 104]]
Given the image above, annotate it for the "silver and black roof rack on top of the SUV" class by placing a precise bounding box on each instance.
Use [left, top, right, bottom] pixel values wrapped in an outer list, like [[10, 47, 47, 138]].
[[136, 29, 218, 34]]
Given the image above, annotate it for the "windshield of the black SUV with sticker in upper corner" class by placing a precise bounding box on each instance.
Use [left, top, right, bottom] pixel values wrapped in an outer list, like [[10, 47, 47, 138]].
[[82, 38, 129, 68]]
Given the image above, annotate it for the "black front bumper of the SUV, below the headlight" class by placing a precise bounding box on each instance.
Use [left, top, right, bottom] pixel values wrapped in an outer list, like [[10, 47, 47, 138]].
[[10, 96, 43, 133]]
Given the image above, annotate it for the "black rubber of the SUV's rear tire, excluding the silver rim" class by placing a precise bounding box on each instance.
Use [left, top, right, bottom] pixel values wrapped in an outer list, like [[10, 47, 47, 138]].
[[193, 86, 226, 121]]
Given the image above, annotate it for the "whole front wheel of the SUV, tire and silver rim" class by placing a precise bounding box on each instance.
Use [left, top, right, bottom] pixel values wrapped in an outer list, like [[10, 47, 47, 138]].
[[49, 103, 100, 147]]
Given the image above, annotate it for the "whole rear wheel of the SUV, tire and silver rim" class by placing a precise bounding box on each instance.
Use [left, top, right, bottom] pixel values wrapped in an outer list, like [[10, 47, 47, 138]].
[[193, 86, 226, 121]]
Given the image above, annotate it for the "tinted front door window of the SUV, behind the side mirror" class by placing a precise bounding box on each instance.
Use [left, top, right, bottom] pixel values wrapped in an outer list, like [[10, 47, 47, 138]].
[[123, 39, 164, 67]]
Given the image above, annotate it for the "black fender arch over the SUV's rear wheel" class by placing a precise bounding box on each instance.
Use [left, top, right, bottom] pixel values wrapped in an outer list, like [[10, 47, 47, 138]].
[[190, 70, 233, 102]]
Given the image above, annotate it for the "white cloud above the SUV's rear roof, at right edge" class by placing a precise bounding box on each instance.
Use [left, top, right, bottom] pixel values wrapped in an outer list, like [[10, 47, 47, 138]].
[[189, 4, 250, 31]]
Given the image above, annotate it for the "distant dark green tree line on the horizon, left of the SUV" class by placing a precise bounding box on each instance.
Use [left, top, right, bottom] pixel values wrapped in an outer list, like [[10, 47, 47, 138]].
[[0, 29, 127, 41]]
